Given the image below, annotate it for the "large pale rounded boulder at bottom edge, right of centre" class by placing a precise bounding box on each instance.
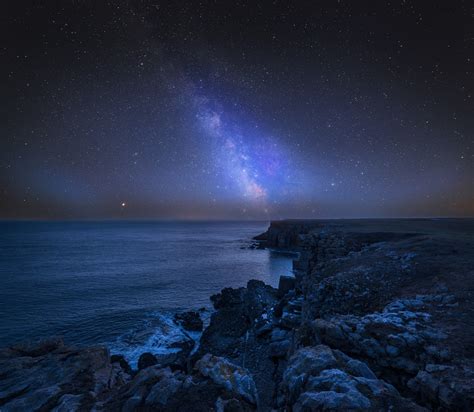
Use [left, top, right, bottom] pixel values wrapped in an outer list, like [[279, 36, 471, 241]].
[[280, 345, 422, 411]]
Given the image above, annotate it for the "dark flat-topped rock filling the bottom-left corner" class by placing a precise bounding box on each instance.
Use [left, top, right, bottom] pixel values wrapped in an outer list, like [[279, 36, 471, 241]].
[[0, 339, 130, 411]]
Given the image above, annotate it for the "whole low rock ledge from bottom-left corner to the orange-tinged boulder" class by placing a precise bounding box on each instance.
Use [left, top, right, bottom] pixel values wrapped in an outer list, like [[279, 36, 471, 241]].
[[0, 340, 258, 411]]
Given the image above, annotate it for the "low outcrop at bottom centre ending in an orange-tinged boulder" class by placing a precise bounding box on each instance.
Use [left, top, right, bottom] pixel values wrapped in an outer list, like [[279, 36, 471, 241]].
[[103, 354, 258, 412]]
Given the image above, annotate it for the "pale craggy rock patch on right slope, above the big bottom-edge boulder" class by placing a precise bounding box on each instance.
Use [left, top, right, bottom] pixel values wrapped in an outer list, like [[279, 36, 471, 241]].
[[312, 298, 448, 374]]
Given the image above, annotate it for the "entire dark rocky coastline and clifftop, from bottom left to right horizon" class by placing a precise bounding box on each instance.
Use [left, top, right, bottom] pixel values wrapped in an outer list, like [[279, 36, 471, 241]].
[[0, 219, 474, 411]]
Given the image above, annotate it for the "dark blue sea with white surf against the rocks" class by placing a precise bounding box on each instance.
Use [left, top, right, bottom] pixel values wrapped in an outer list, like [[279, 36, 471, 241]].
[[0, 221, 293, 362]]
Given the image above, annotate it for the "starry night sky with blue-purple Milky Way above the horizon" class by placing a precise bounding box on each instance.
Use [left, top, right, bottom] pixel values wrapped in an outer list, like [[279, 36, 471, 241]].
[[0, 0, 474, 219]]
